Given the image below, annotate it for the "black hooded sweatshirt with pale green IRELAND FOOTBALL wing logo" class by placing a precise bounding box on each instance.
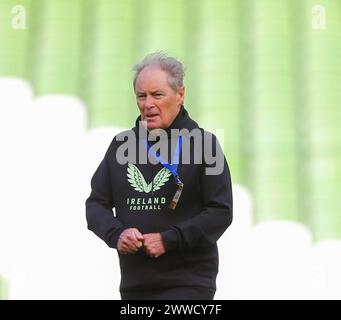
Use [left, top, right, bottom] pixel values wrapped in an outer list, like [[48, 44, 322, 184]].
[[86, 106, 232, 293]]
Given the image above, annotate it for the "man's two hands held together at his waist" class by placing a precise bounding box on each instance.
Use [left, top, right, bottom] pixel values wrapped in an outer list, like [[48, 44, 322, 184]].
[[117, 228, 166, 258]]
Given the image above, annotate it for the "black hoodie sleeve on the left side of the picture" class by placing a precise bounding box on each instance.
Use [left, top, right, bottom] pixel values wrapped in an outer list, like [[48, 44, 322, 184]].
[[85, 142, 125, 248]]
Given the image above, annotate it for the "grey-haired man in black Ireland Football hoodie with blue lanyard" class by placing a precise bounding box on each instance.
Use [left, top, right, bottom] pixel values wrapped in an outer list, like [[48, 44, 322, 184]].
[[86, 53, 232, 300]]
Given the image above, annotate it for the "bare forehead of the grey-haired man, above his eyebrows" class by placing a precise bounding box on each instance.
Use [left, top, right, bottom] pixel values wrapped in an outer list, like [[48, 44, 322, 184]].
[[136, 66, 170, 90]]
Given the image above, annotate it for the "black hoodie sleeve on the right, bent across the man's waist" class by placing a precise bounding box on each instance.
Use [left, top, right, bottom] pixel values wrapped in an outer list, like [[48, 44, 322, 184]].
[[161, 135, 233, 251]]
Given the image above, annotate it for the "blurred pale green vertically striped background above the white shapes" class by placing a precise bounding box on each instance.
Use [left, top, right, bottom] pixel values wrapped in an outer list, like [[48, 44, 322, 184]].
[[0, 0, 341, 240]]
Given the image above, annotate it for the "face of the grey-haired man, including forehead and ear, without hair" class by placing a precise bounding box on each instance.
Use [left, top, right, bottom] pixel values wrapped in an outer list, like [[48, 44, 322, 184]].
[[135, 66, 185, 129]]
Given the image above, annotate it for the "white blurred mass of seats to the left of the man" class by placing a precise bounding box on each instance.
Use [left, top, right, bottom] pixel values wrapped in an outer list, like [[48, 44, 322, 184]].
[[0, 80, 119, 299]]
